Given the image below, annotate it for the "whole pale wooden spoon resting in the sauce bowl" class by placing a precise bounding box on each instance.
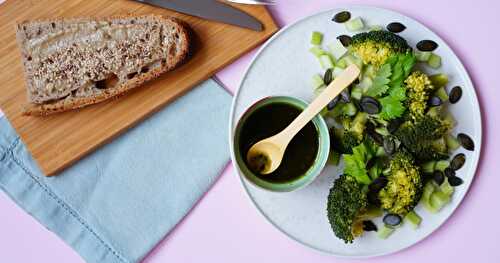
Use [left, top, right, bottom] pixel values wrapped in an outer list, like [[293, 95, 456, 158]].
[[247, 65, 360, 174]]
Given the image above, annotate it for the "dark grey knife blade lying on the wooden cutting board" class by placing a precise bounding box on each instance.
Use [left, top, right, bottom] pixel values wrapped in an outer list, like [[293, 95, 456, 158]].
[[135, 0, 263, 31]]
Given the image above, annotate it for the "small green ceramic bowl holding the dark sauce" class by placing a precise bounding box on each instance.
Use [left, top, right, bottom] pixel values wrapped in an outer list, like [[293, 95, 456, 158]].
[[232, 96, 330, 192]]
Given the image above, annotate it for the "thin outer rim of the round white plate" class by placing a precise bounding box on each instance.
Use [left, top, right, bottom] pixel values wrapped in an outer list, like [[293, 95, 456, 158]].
[[228, 4, 483, 259]]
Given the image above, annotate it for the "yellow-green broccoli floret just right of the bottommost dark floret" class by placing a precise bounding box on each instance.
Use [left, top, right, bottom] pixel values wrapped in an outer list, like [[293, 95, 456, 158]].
[[379, 151, 423, 216]]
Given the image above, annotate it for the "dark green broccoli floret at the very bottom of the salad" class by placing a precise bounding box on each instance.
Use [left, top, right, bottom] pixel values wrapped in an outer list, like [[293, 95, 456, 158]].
[[326, 175, 368, 243]]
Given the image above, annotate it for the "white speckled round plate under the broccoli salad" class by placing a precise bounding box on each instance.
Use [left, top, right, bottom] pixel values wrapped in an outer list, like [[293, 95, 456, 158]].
[[230, 6, 482, 258]]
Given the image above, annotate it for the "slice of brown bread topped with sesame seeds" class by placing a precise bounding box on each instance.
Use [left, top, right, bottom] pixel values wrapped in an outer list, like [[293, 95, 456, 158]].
[[17, 15, 190, 116]]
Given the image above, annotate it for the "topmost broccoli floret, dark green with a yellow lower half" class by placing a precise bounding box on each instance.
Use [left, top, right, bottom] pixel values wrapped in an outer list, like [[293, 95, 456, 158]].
[[350, 30, 411, 67]]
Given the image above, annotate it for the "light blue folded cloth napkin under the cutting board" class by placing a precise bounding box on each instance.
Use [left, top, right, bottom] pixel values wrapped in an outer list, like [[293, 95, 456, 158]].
[[0, 80, 231, 263]]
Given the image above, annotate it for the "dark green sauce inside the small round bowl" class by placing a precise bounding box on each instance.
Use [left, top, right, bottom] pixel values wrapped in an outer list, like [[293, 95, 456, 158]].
[[238, 102, 319, 183]]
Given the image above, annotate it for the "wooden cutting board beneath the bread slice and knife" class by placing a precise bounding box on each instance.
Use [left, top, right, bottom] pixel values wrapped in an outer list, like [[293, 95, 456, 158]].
[[0, 0, 277, 175]]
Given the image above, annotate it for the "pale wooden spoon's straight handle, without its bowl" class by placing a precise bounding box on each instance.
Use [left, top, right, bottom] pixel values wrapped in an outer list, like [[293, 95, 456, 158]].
[[279, 64, 360, 145]]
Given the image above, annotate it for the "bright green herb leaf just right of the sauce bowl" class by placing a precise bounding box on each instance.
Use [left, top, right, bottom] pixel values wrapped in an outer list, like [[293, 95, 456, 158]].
[[344, 143, 371, 184]]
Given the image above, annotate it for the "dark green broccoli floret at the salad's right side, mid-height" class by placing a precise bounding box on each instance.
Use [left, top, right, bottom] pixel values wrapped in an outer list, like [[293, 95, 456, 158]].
[[395, 115, 451, 162]]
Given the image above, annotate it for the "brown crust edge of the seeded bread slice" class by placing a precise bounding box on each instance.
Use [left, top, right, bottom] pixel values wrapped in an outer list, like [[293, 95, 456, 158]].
[[17, 15, 191, 116]]
